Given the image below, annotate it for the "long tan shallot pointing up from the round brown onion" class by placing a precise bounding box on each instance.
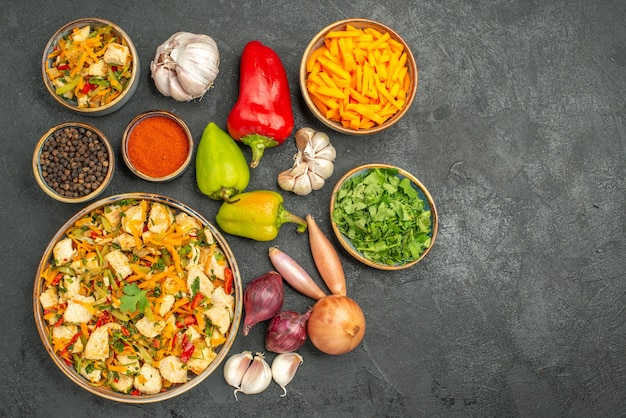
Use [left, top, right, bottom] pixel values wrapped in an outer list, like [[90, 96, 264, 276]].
[[306, 214, 346, 296]]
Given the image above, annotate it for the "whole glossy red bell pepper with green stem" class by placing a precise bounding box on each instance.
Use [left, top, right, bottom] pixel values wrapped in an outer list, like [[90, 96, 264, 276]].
[[226, 40, 294, 168]]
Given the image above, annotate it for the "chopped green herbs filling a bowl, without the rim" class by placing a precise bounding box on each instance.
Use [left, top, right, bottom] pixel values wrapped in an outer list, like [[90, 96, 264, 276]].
[[332, 168, 432, 265]]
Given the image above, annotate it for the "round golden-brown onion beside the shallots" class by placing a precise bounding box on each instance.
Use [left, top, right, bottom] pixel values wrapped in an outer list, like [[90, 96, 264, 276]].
[[307, 295, 365, 355]]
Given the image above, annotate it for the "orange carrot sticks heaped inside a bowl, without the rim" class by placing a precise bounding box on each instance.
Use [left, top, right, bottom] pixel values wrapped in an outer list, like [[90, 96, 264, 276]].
[[305, 25, 411, 130]]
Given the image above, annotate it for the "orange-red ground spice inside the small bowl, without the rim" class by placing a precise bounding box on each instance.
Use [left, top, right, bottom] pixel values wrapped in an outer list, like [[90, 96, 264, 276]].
[[127, 116, 189, 177]]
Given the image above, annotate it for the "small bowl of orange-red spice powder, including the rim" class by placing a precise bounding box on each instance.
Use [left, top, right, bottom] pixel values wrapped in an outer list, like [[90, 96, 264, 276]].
[[122, 110, 193, 182]]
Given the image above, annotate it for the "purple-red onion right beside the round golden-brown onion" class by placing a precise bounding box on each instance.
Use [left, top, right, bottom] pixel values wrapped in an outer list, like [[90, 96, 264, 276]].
[[265, 309, 311, 353]]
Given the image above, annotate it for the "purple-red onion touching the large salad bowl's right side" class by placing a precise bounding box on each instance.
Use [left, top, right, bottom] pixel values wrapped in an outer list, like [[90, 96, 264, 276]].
[[243, 271, 285, 335]]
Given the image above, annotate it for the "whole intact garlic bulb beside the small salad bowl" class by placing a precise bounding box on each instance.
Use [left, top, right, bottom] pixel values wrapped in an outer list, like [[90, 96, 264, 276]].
[[150, 32, 220, 102]]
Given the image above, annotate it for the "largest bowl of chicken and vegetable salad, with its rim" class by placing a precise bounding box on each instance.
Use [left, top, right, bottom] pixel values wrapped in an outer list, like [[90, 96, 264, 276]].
[[33, 193, 243, 403]]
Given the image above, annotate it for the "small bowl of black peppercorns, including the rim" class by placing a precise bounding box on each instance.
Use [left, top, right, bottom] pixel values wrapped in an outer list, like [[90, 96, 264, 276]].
[[33, 122, 115, 203]]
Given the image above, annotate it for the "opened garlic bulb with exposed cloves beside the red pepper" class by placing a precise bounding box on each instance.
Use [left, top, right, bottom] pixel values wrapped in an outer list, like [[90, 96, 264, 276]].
[[278, 128, 337, 196]]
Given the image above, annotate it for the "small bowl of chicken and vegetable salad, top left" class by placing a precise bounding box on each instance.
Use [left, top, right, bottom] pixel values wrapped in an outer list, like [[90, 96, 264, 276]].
[[41, 18, 139, 116]]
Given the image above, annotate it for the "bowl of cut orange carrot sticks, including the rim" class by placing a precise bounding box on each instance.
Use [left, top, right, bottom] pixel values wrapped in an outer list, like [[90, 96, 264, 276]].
[[300, 18, 418, 135]]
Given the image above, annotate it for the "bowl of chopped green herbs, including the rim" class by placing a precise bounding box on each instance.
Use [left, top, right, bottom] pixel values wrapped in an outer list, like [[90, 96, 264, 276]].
[[330, 164, 438, 270]]
